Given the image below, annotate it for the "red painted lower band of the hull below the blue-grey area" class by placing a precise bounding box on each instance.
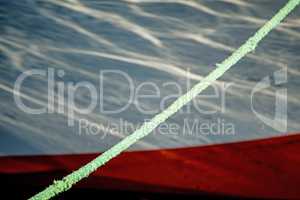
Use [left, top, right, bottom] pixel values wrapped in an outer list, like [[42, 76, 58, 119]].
[[0, 134, 300, 198]]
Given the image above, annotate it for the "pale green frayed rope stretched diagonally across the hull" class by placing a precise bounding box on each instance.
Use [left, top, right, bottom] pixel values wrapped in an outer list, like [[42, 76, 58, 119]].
[[30, 0, 300, 200]]
